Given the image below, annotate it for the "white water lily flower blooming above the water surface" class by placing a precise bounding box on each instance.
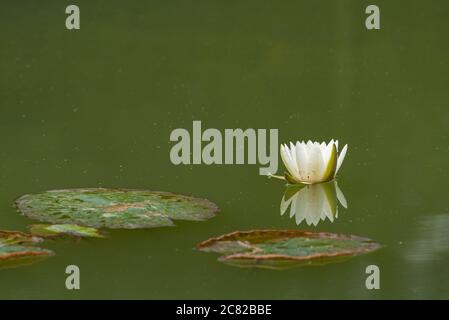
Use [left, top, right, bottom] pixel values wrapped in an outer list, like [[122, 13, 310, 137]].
[[281, 139, 348, 184]]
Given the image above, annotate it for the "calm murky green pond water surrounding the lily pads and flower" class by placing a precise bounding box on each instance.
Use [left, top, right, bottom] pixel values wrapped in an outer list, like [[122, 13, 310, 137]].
[[0, 0, 449, 299]]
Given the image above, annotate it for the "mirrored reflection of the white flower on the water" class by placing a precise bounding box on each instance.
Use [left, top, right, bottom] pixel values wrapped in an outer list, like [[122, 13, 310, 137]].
[[281, 180, 348, 226]]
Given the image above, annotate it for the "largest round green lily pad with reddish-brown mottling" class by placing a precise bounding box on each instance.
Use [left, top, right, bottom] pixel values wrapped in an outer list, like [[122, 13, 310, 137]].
[[16, 188, 218, 229]]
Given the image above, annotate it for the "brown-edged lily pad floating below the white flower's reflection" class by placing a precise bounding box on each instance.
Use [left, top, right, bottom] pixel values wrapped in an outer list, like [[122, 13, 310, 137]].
[[196, 230, 380, 269]]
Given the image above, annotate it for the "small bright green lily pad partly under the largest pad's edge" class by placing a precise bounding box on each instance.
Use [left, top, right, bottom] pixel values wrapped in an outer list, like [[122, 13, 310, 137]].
[[30, 224, 104, 238]]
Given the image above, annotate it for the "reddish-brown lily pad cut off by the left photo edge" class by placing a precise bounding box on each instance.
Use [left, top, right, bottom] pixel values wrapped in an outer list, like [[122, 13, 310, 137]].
[[0, 231, 53, 269]]
